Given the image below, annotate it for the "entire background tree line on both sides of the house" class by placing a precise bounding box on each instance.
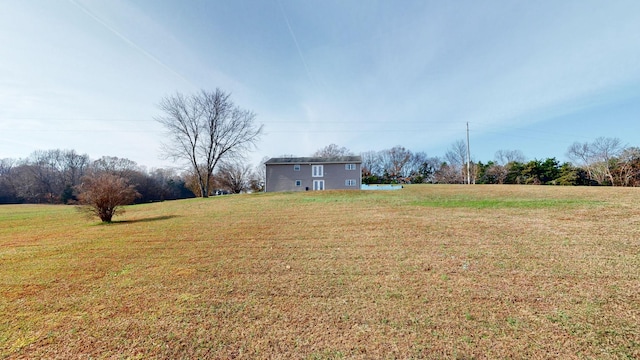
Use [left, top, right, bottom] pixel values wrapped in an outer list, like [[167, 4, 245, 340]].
[[0, 138, 640, 204]]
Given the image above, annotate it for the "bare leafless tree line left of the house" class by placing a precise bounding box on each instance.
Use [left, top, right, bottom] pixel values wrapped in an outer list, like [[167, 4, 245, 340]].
[[0, 149, 272, 204]]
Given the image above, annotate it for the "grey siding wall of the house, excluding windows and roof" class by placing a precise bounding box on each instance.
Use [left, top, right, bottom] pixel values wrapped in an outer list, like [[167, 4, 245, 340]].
[[266, 163, 362, 192]]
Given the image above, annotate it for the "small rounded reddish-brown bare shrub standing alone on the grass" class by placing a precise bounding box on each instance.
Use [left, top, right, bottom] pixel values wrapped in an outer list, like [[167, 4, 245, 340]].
[[78, 172, 140, 222]]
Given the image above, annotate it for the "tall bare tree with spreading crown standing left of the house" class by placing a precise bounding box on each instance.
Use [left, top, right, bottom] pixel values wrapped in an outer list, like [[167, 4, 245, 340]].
[[156, 89, 262, 197]]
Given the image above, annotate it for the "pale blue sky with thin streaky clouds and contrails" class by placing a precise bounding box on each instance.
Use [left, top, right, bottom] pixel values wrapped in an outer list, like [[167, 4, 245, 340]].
[[0, 0, 640, 169]]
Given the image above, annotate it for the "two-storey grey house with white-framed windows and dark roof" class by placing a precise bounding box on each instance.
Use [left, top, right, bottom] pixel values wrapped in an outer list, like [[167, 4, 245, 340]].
[[265, 156, 362, 192]]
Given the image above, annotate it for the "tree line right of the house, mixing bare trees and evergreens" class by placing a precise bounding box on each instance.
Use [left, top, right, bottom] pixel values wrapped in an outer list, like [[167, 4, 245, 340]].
[[361, 137, 640, 186]]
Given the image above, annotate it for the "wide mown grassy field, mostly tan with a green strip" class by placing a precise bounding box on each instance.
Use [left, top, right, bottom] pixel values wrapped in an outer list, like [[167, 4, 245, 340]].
[[0, 185, 640, 359]]
